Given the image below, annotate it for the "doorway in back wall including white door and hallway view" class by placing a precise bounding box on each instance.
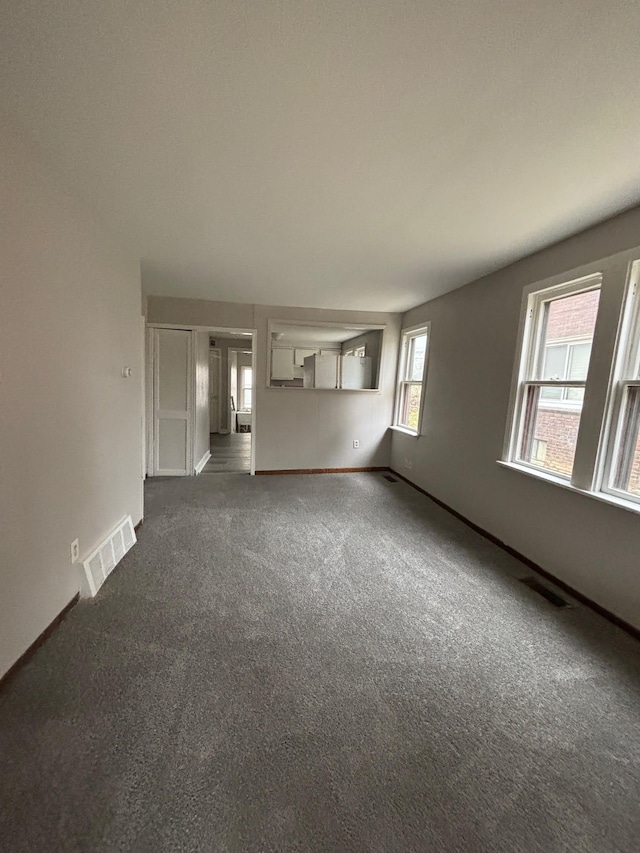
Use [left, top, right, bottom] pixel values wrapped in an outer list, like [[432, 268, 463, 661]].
[[147, 324, 256, 477]]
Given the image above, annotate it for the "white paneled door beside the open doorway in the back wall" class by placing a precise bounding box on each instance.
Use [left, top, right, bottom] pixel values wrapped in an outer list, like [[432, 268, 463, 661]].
[[153, 329, 192, 476]]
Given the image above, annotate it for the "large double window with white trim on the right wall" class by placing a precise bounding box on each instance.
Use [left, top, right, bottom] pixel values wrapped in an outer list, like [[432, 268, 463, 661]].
[[503, 251, 640, 509]]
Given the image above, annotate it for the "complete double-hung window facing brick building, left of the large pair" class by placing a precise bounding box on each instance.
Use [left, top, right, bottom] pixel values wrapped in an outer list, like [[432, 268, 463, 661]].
[[504, 275, 601, 479]]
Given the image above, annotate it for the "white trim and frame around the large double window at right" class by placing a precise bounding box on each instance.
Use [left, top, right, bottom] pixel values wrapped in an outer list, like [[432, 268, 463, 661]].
[[498, 243, 640, 512]]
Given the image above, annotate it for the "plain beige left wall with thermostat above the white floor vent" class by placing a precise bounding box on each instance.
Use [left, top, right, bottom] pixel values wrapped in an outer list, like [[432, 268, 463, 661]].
[[0, 122, 142, 674]]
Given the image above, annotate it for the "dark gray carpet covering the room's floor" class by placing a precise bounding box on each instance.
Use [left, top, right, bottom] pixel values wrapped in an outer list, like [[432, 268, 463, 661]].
[[0, 474, 640, 853]]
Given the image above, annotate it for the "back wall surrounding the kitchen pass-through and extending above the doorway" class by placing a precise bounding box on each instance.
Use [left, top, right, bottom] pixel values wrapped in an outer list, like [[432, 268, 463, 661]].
[[148, 296, 400, 471]]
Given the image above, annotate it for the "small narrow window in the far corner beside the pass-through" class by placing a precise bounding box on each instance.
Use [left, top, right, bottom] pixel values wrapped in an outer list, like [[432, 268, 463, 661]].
[[394, 324, 429, 435]]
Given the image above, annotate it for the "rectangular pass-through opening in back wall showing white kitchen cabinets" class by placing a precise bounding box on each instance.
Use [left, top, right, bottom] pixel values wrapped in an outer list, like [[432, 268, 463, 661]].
[[268, 320, 384, 391]]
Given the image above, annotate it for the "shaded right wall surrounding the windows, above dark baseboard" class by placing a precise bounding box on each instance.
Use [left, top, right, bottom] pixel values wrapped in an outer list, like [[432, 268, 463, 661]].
[[392, 209, 640, 627]]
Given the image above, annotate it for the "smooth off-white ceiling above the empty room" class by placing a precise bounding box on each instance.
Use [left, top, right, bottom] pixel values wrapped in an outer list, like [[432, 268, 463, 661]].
[[0, 0, 640, 310]]
